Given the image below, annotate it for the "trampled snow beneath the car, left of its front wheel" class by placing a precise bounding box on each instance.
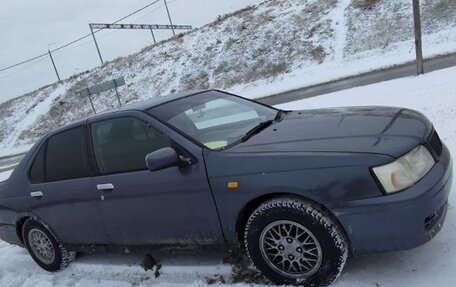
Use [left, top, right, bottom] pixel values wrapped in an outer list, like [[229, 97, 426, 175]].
[[0, 241, 231, 287]]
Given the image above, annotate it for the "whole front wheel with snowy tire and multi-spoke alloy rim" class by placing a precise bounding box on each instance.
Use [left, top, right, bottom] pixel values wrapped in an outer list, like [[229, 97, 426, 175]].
[[244, 198, 348, 286]]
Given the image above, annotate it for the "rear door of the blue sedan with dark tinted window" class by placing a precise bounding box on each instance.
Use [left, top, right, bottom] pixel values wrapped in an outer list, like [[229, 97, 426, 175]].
[[28, 125, 108, 245]]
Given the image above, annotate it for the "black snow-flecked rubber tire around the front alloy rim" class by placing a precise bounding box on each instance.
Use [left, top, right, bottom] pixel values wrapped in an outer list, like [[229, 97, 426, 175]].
[[244, 198, 348, 287]]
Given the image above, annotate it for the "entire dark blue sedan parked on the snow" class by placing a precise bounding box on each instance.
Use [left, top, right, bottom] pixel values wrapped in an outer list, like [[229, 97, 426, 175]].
[[0, 90, 452, 286]]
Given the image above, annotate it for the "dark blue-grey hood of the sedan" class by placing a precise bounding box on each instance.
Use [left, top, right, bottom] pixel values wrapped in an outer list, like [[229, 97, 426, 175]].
[[228, 107, 432, 157]]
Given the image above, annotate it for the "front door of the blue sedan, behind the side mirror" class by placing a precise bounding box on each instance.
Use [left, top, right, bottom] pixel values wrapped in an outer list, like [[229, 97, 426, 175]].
[[89, 112, 223, 245]]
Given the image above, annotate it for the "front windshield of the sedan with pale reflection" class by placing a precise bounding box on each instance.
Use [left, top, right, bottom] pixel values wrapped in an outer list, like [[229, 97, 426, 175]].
[[148, 91, 280, 150]]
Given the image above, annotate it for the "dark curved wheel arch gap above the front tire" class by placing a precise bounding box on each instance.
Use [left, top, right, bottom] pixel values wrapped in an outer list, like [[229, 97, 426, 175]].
[[236, 192, 351, 250]]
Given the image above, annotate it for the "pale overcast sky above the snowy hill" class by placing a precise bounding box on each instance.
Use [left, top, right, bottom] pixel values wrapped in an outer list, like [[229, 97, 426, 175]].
[[0, 0, 262, 102]]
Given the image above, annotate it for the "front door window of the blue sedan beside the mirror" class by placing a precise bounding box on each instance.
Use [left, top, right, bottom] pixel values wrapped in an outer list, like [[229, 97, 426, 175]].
[[91, 117, 171, 174]]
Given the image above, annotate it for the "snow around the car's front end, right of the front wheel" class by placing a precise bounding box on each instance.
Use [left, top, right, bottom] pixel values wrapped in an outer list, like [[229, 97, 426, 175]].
[[280, 68, 456, 287]]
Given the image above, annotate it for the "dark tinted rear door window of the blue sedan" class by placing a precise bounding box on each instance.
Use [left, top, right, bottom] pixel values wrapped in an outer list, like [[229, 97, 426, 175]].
[[46, 127, 86, 181]]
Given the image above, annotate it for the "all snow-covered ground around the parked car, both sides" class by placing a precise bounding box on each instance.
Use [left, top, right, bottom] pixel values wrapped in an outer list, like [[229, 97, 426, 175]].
[[0, 67, 456, 287]]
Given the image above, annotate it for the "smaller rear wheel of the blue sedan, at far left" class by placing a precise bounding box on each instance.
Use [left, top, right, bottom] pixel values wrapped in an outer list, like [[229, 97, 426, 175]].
[[22, 219, 76, 272]]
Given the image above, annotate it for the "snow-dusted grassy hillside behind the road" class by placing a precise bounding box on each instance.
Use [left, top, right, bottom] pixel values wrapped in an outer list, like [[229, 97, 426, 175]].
[[0, 0, 456, 155]]
